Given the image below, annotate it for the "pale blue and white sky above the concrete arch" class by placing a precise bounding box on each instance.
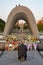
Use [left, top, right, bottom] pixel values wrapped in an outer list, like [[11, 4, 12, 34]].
[[0, 0, 43, 21]]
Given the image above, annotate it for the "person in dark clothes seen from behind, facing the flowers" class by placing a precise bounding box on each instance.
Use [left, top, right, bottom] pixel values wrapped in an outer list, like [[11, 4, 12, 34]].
[[18, 41, 27, 60]]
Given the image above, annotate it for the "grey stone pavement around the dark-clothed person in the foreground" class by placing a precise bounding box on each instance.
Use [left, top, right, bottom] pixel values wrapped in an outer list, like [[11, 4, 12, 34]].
[[0, 51, 43, 65]]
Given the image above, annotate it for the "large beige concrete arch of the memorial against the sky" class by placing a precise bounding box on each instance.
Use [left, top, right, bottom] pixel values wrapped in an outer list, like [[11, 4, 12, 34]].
[[3, 6, 39, 38]]
